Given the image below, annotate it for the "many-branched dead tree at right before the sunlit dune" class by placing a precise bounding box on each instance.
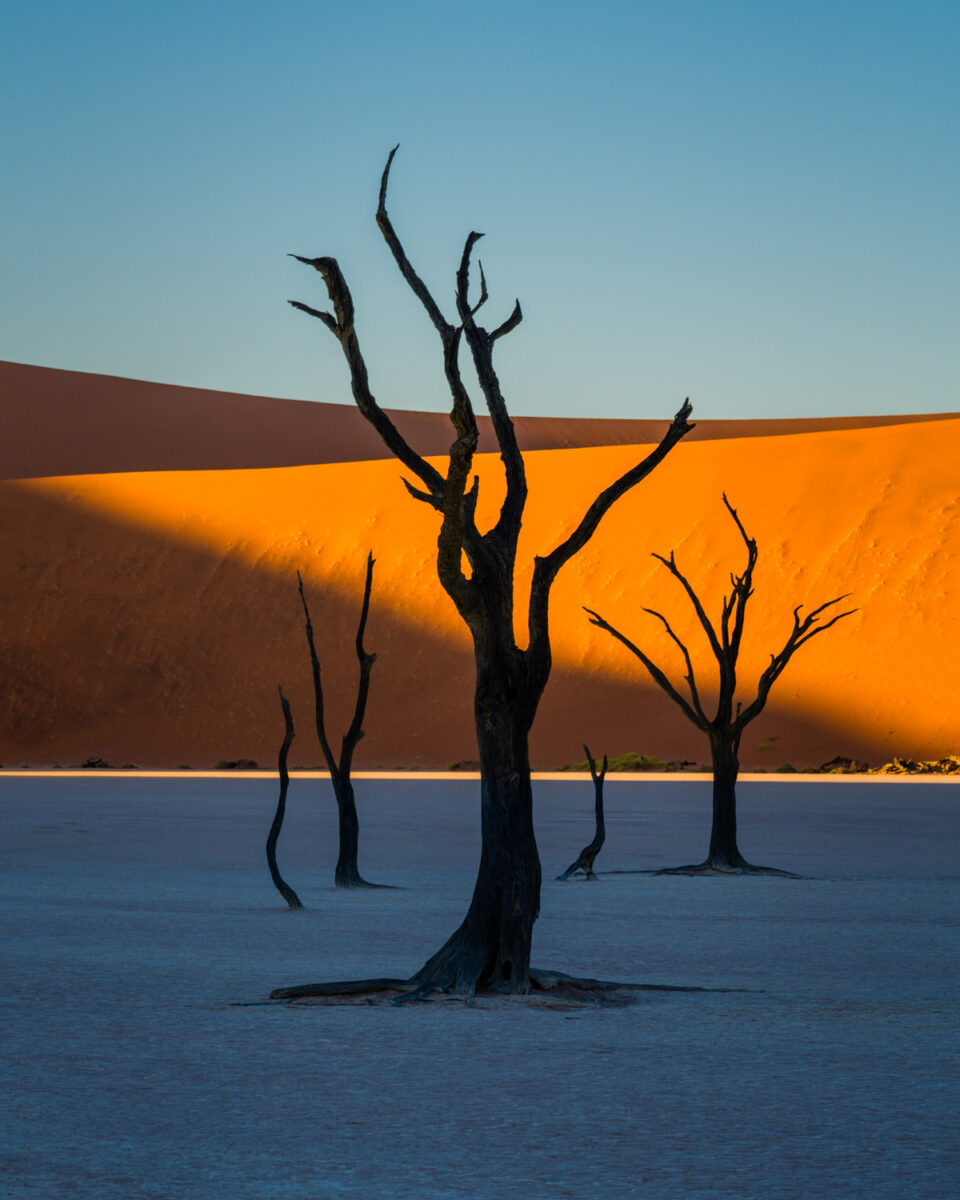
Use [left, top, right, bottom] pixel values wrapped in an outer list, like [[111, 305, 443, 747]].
[[586, 496, 857, 875]]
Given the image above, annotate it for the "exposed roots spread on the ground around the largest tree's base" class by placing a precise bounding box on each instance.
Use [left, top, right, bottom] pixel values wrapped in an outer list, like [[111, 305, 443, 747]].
[[266, 967, 744, 1007]]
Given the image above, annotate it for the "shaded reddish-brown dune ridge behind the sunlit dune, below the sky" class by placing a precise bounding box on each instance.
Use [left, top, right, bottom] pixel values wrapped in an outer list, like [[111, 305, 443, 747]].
[[0, 362, 956, 479]]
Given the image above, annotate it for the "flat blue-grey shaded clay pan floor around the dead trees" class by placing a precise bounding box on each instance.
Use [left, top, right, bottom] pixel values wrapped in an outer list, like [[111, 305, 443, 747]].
[[0, 775, 960, 1200]]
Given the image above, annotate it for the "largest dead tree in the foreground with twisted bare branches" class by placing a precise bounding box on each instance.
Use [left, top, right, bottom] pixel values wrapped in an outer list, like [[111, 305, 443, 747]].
[[275, 148, 692, 998]]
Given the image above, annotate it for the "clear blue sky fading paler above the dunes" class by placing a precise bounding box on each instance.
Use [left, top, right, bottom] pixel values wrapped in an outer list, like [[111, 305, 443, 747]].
[[0, 0, 960, 418]]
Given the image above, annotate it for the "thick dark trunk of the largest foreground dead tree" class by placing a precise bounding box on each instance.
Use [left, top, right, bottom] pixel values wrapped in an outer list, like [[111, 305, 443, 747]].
[[413, 652, 541, 994]]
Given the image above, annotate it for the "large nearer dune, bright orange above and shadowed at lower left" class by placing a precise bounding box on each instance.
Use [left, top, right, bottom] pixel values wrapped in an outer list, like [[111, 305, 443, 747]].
[[0, 420, 960, 767]]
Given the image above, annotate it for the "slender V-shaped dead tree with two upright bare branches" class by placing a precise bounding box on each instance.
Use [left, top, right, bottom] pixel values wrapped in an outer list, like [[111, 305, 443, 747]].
[[296, 554, 384, 888]]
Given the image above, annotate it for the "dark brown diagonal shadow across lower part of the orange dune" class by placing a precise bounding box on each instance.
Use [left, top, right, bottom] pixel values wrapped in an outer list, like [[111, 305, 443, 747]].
[[0, 485, 902, 768]]
